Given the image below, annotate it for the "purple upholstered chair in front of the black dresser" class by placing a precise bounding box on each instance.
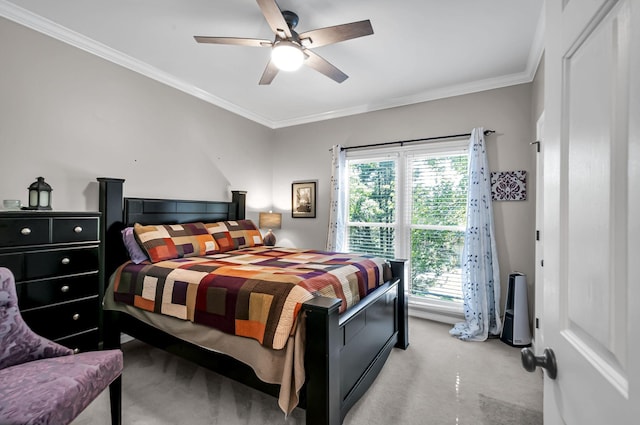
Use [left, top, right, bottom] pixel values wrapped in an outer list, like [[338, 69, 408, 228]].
[[0, 267, 122, 425]]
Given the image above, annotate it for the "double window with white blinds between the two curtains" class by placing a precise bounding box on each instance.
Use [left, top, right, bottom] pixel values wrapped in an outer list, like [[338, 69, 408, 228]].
[[347, 142, 468, 305]]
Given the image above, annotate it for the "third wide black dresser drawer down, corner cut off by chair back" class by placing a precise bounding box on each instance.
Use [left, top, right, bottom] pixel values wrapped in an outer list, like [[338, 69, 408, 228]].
[[22, 295, 99, 339]]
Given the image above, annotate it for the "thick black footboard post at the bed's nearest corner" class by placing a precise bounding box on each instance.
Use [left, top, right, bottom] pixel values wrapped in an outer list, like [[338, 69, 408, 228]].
[[303, 297, 342, 425]]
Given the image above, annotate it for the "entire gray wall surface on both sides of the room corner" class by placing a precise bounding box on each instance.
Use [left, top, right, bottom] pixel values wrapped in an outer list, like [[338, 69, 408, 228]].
[[0, 18, 537, 314]]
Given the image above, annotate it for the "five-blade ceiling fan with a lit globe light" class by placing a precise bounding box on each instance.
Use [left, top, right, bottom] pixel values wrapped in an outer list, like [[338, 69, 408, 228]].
[[194, 0, 373, 85]]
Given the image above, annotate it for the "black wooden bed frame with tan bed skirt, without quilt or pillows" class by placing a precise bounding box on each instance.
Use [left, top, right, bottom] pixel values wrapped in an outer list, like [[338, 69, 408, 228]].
[[98, 178, 409, 425]]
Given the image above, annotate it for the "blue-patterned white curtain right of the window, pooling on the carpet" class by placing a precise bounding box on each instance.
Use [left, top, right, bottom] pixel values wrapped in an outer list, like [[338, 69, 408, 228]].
[[449, 128, 502, 341]]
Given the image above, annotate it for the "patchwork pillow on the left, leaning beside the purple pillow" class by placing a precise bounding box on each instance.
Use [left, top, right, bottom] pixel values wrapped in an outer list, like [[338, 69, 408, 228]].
[[133, 223, 218, 263]]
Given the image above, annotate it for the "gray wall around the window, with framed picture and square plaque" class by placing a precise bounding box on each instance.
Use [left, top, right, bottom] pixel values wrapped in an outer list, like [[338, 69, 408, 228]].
[[273, 84, 535, 303]]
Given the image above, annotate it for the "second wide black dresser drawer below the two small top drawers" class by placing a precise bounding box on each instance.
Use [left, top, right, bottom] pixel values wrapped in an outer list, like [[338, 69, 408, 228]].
[[16, 272, 98, 309]]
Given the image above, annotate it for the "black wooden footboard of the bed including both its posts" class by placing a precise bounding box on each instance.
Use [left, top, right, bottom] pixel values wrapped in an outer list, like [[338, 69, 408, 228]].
[[304, 260, 409, 425]]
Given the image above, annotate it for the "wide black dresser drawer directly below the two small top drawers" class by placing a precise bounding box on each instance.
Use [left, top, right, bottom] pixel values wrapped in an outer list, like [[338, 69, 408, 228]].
[[24, 246, 99, 279]]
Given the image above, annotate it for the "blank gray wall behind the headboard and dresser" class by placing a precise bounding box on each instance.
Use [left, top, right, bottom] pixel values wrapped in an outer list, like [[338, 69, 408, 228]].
[[0, 18, 274, 219]]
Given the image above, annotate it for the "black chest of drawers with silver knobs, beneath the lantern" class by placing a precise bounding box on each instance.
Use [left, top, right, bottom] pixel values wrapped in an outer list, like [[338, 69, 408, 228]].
[[0, 211, 101, 352]]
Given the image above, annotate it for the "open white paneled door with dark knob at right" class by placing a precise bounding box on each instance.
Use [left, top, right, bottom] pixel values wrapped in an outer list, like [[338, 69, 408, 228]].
[[542, 0, 640, 425]]
